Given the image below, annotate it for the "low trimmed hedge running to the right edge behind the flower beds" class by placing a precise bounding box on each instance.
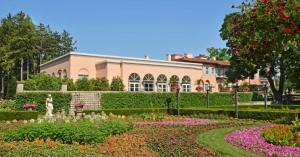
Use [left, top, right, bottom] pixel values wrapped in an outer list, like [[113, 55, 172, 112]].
[[171, 109, 300, 120]]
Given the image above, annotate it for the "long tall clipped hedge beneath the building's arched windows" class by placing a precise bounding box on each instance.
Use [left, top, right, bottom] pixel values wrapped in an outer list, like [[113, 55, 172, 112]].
[[101, 92, 253, 109]]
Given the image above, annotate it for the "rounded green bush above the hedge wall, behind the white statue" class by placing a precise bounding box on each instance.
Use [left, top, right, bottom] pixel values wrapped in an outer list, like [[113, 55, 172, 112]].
[[24, 73, 61, 91]]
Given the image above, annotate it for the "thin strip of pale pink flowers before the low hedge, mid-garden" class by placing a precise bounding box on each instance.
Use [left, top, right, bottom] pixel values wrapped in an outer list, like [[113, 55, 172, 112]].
[[133, 118, 215, 125]]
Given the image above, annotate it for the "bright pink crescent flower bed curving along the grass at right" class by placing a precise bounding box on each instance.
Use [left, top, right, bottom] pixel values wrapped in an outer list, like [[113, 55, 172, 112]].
[[224, 125, 300, 157]]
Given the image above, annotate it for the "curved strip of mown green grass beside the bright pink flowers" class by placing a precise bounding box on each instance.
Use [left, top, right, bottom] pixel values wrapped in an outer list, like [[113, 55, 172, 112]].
[[197, 126, 256, 157]]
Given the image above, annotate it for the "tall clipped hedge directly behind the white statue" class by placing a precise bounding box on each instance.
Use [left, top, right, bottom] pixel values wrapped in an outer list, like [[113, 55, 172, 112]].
[[16, 92, 72, 113]]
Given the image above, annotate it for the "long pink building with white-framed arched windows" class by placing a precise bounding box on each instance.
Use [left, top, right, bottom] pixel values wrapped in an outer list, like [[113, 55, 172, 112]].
[[41, 52, 259, 92]]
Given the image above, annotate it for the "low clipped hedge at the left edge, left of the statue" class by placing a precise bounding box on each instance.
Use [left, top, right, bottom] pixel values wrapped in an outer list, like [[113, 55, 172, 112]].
[[0, 111, 39, 121]]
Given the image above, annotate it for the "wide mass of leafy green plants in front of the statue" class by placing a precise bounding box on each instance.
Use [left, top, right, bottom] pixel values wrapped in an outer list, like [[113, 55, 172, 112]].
[[4, 120, 131, 144]]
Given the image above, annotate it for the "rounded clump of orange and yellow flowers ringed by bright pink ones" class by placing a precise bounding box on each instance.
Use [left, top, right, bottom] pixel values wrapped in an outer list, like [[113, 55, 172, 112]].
[[262, 125, 300, 147]]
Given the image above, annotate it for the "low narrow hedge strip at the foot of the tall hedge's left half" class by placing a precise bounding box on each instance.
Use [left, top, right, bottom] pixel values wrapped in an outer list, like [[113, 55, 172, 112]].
[[83, 108, 168, 115]]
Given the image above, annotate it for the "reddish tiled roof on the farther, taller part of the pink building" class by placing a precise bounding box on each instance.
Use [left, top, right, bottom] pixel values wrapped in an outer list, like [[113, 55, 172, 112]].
[[173, 57, 230, 66]]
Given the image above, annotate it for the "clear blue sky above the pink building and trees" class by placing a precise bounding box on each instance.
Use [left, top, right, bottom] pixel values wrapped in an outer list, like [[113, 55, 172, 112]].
[[0, 0, 242, 59]]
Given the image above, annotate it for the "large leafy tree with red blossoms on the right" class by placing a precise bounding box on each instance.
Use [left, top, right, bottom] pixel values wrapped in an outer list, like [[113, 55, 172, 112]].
[[220, 0, 300, 102]]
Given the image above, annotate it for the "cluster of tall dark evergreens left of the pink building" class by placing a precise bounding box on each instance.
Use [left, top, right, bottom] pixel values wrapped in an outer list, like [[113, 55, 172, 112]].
[[0, 12, 76, 96]]
